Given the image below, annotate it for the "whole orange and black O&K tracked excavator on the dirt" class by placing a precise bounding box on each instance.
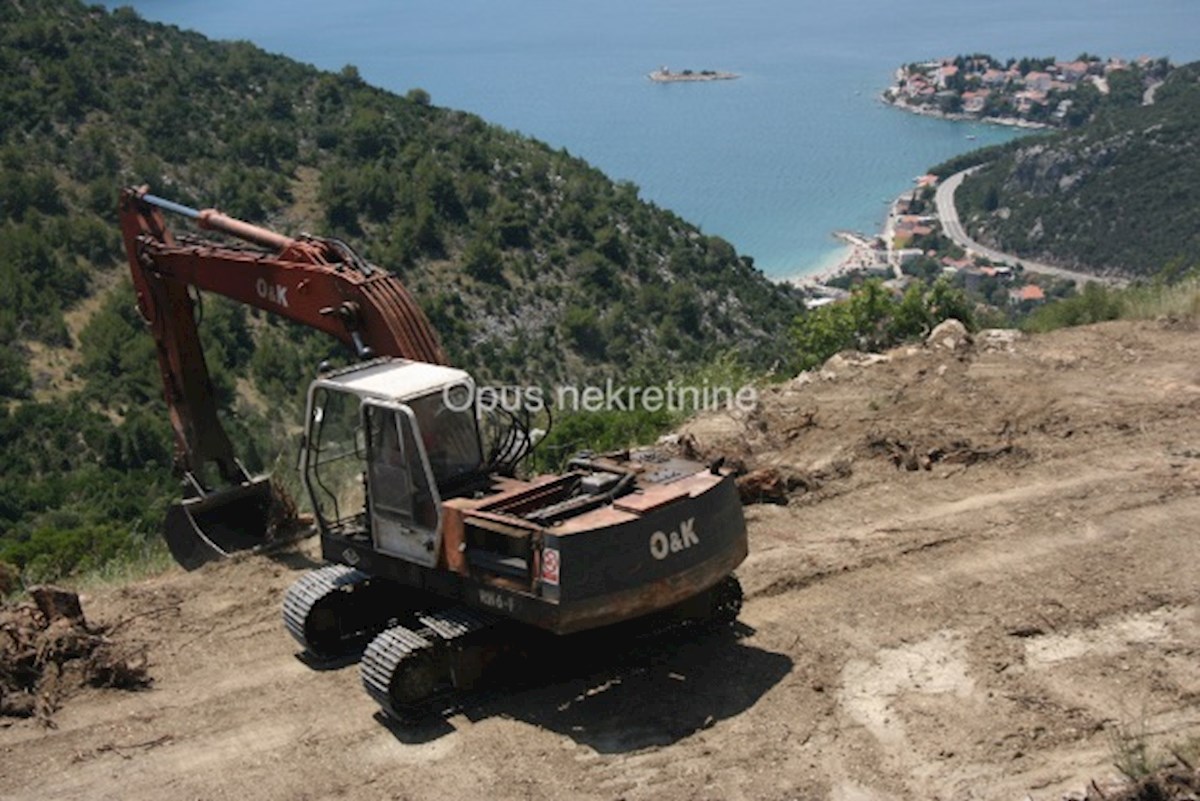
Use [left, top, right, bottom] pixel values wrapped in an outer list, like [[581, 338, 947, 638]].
[[119, 187, 748, 721]]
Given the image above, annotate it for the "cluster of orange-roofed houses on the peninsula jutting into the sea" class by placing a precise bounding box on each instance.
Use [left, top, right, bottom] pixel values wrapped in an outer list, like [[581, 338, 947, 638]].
[[882, 53, 1172, 127]]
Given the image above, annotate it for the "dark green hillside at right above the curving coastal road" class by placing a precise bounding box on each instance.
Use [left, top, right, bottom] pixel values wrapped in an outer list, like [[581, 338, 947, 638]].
[[942, 64, 1200, 277]]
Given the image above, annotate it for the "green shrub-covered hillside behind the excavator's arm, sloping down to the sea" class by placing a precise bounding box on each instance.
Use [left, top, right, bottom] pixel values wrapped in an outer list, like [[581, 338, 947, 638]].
[[0, 0, 798, 574]]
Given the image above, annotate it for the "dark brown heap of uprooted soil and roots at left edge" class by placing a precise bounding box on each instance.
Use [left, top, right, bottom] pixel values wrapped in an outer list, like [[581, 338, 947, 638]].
[[0, 586, 150, 721]]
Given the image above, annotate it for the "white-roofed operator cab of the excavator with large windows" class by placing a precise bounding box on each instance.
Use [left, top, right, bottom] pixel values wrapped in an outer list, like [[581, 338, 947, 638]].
[[301, 359, 484, 567]]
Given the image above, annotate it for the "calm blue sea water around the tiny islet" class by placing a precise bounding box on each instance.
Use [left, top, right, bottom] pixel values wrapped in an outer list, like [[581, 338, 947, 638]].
[[121, 0, 1200, 277]]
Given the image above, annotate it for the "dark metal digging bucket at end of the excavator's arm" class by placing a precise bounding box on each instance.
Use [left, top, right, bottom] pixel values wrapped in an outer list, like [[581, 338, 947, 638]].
[[163, 476, 276, 570]]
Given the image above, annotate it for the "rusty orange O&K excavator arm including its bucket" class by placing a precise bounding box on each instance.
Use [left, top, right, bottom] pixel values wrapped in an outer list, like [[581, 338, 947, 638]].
[[120, 187, 445, 568]]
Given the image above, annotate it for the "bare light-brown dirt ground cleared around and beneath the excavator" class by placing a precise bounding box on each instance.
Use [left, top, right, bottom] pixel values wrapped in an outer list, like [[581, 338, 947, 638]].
[[0, 323, 1200, 801]]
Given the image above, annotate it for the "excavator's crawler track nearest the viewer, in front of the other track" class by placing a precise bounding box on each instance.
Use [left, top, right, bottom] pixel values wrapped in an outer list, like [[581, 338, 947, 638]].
[[360, 607, 498, 721]]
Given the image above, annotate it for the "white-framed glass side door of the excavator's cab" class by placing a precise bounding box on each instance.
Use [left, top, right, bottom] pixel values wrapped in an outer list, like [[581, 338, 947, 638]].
[[362, 399, 442, 567]]
